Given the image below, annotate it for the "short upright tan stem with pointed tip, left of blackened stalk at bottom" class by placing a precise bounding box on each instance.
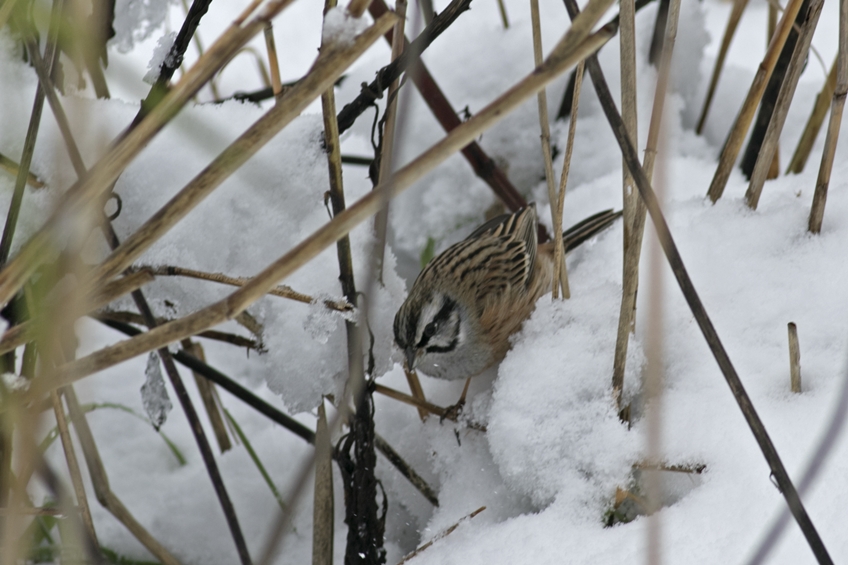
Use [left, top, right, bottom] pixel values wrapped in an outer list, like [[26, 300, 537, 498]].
[[312, 400, 335, 565]]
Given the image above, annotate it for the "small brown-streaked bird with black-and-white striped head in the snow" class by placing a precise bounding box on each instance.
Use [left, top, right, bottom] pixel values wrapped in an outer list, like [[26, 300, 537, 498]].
[[393, 204, 621, 396]]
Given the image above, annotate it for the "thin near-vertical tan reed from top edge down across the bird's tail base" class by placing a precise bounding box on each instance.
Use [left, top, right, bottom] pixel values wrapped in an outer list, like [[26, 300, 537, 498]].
[[530, 0, 571, 300]]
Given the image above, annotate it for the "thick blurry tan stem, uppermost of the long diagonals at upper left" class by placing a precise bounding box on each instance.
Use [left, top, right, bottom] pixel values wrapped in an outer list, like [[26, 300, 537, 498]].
[[0, 0, 293, 304]]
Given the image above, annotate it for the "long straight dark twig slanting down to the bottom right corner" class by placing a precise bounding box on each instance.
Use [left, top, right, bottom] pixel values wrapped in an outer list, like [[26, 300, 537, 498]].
[[565, 0, 833, 563]]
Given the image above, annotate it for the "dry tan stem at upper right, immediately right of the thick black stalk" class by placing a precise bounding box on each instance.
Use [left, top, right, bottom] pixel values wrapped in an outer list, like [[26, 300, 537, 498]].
[[745, 0, 824, 210]]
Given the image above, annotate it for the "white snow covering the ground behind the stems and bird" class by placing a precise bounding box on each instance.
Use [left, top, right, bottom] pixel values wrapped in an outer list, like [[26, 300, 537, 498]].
[[0, 0, 848, 565]]
